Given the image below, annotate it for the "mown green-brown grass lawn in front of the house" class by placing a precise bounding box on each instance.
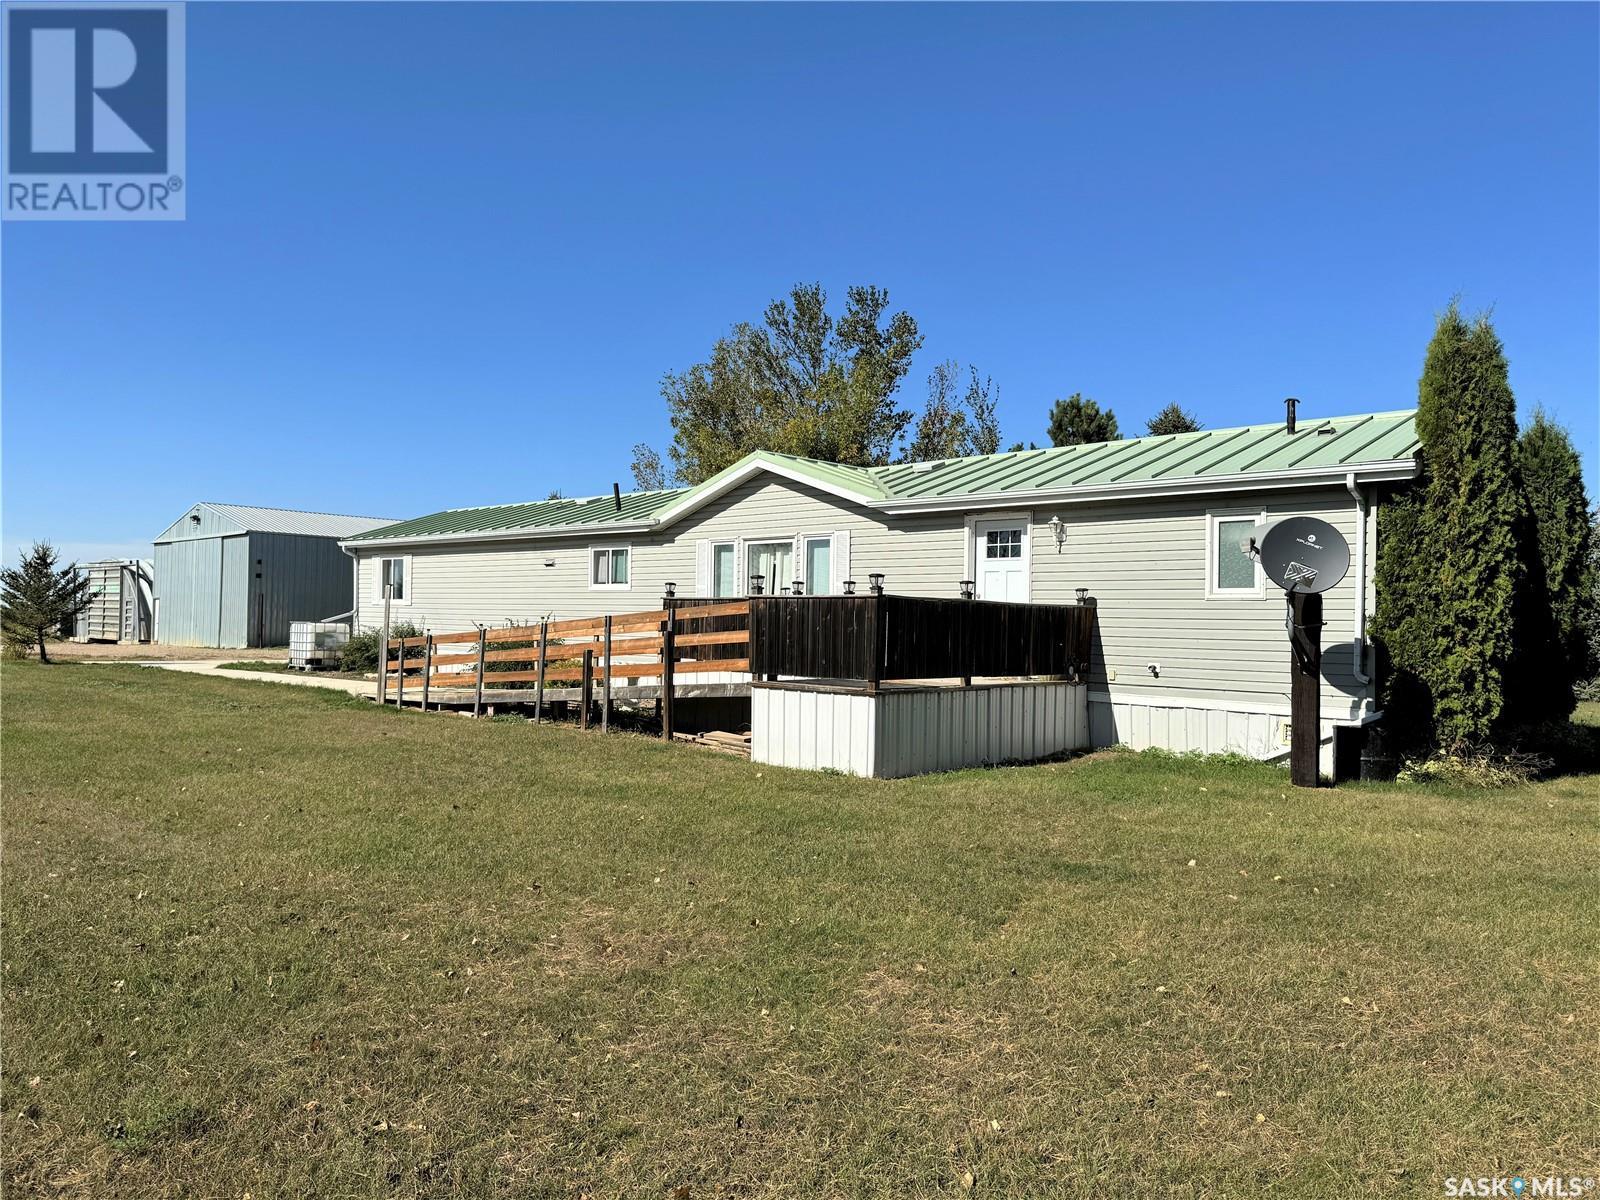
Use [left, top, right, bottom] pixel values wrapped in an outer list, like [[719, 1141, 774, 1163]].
[[0, 664, 1600, 1200]]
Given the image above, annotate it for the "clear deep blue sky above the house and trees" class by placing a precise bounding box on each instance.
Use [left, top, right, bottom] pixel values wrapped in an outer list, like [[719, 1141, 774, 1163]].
[[0, 3, 1600, 558]]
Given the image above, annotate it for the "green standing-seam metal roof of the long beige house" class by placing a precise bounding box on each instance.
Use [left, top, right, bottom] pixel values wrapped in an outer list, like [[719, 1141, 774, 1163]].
[[347, 411, 1418, 542]]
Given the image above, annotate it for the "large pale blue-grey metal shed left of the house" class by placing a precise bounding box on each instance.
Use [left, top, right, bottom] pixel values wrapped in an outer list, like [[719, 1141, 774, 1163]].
[[155, 502, 392, 646]]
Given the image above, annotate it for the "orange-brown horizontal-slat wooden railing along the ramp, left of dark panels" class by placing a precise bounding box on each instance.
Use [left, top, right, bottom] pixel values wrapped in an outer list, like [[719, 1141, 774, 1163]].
[[378, 600, 750, 738]]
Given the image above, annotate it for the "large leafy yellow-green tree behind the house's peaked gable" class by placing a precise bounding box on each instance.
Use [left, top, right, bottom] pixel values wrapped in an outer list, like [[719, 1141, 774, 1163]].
[[661, 283, 922, 483]]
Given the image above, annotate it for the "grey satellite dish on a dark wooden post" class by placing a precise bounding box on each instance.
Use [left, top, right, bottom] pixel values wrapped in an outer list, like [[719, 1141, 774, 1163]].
[[1246, 517, 1350, 787]]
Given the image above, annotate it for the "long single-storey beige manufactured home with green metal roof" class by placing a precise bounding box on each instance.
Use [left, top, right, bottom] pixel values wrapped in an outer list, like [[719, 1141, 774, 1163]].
[[342, 411, 1418, 757]]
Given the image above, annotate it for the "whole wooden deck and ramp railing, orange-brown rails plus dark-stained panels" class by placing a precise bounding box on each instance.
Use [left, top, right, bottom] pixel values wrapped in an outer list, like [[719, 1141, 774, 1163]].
[[374, 590, 1094, 739]]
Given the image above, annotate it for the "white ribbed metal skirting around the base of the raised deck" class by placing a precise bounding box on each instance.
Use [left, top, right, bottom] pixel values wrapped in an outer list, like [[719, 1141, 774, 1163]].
[[750, 682, 1090, 779]]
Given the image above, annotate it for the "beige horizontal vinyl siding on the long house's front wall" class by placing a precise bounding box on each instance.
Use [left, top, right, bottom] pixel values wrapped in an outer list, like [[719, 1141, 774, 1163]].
[[357, 477, 1376, 720]]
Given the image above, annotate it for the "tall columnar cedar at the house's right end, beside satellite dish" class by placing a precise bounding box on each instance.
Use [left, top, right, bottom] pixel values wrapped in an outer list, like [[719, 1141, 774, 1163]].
[[1373, 302, 1525, 750]]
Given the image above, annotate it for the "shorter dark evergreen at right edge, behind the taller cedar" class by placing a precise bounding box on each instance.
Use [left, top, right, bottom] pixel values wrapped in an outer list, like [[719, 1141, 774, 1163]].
[[1517, 410, 1600, 683]]
